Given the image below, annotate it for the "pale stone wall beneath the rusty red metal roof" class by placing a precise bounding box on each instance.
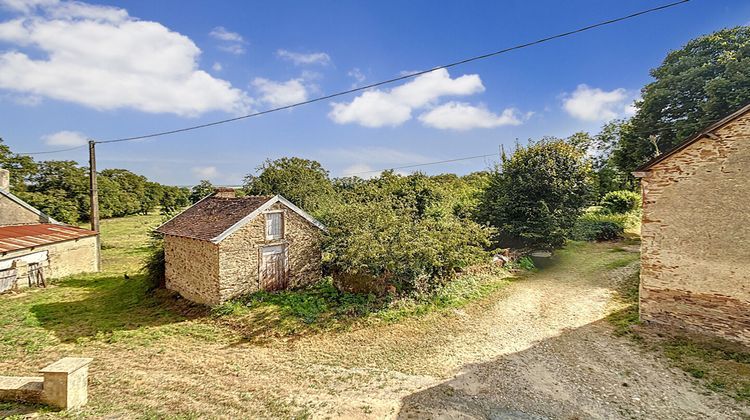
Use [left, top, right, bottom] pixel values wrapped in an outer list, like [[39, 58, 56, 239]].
[[0, 236, 99, 287]]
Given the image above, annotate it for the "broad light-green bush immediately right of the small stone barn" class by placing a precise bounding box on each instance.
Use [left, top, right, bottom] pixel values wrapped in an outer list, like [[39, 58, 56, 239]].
[[322, 172, 489, 292]]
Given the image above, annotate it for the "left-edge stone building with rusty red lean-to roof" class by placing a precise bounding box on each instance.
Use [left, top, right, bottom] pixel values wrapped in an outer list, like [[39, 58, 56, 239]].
[[0, 169, 99, 292]]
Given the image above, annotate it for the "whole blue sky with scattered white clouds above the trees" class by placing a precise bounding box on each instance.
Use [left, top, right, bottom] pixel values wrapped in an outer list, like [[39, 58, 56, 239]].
[[0, 0, 750, 185]]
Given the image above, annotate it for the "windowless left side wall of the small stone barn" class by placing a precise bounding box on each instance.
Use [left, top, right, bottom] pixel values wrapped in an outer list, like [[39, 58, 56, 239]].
[[164, 235, 221, 305]]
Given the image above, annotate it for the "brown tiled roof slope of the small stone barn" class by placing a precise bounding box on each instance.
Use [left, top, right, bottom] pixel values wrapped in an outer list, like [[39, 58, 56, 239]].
[[156, 196, 273, 241]]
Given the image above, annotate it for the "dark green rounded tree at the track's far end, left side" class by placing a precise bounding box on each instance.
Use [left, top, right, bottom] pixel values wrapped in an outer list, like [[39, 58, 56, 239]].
[[478, 138, 592, 249]]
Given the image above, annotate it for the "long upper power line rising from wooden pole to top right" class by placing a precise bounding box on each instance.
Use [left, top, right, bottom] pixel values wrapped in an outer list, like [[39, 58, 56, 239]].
[[16, 0, 690, 154]]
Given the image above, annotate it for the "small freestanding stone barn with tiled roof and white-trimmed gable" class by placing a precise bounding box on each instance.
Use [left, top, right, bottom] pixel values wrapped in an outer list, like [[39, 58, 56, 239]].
[[156, 188, 325, 305]]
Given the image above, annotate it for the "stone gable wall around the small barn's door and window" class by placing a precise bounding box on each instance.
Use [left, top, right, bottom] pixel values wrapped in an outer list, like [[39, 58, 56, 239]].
[[219, 203, 321, 300]]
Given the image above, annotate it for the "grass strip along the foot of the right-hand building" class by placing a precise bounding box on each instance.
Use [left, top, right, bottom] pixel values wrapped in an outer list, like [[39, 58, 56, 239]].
[[608, 264, 750, 403]]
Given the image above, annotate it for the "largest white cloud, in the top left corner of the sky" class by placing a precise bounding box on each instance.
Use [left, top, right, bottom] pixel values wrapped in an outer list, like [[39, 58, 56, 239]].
[[0, 0, 250, 116]]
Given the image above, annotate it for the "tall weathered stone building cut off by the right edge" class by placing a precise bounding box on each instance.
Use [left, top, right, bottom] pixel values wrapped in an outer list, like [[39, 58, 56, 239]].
[[634, 105, 750, 344]]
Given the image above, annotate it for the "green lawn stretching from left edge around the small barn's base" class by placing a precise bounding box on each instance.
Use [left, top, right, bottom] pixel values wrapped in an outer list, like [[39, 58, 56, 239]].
[[0, 214, 509, 362]]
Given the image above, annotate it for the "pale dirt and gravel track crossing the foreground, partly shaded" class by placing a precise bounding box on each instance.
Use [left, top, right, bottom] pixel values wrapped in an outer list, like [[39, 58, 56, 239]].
[[8, 244, 750, 419]]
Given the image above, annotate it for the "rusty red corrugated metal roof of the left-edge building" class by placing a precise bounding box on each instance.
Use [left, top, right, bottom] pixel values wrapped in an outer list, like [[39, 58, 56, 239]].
[[0, 224, 96, 252]]
